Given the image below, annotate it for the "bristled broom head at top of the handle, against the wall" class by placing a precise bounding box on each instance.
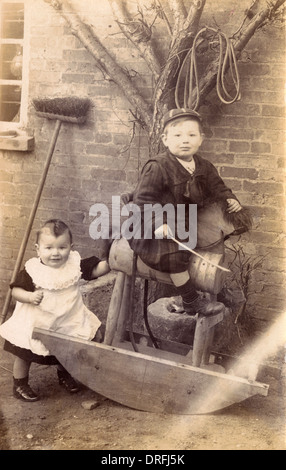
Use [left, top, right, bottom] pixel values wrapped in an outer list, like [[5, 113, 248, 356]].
[[33, 97, 91, 124]]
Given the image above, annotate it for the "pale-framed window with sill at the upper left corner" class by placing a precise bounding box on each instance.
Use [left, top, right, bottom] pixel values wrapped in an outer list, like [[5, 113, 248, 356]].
[[0, 0, 32, 150]]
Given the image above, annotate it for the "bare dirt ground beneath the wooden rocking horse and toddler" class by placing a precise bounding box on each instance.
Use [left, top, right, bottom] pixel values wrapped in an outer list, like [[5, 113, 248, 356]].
[[0, 336, 286, 451]]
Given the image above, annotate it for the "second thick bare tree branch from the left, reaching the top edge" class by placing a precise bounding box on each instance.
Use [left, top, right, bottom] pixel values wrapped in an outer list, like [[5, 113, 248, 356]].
[[109, 0, 161, 81]]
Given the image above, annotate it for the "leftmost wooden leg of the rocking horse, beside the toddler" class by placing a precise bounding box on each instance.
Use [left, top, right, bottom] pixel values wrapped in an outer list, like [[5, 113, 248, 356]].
[[103, 272, 126, 346]]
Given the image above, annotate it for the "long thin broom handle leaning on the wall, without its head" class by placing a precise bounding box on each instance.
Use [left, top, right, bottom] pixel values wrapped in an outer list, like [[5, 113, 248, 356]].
[[0, 119, 62, 324]]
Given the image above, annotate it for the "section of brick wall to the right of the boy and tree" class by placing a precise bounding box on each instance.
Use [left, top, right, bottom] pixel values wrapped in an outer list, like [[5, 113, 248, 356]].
[[197, 14, 286, 319]]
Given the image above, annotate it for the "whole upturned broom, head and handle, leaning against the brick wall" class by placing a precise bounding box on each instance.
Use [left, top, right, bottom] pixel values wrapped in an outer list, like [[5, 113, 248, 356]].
[[0, 97, 90, 324]]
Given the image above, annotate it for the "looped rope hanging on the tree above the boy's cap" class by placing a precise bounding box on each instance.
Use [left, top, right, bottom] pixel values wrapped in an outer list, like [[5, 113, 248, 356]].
[[175, 27, 240, 110]]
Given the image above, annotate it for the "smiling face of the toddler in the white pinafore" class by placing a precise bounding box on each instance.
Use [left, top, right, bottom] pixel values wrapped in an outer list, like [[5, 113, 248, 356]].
[[36, 230, 72, 269]]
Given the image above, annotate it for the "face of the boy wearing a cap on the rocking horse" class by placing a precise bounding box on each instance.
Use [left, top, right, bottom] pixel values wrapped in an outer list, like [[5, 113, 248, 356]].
[[162, 120, 203, 161]]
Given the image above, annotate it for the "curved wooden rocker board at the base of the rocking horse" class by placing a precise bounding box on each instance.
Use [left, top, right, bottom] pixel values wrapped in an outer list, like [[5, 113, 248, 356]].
[[33, 328, 268, 415]]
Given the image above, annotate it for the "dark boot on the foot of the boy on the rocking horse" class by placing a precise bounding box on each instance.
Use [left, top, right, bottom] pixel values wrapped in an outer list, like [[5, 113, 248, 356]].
[[177, 280, 224, 316]]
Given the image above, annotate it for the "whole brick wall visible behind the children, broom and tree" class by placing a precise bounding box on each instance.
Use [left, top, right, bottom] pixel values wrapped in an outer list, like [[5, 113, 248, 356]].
[[0, 0, 286, 324]]
